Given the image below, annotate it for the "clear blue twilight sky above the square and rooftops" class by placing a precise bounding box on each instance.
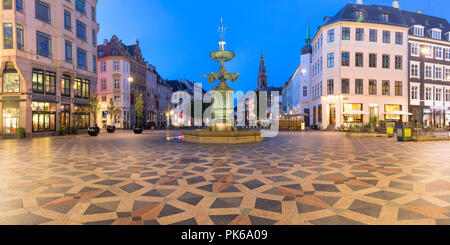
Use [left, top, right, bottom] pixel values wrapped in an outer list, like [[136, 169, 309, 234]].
[[97, 0, 450, 91]]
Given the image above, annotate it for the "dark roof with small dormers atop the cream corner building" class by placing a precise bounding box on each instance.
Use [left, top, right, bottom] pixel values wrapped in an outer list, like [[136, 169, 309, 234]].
[[325, 4, 407, 27]]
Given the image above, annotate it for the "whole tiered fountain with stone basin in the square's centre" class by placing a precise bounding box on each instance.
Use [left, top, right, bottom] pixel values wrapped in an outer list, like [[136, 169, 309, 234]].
[[182, 20, 263, 144]]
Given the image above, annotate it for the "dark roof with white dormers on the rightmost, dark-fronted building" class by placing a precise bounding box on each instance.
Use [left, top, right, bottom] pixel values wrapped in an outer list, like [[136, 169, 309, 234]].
[[402, 11, 450, 41]]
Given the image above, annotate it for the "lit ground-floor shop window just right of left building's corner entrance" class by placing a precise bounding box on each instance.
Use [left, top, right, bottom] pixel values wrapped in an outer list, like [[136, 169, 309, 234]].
[[31, 101, 56, 132]]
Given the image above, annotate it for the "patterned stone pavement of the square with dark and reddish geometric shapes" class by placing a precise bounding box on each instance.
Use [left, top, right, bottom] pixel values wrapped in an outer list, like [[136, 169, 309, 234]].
[[0, 131, 450, 225]]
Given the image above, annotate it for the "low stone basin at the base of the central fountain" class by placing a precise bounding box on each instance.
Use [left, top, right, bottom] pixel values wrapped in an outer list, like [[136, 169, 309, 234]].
[[182, 129, 263, 144]]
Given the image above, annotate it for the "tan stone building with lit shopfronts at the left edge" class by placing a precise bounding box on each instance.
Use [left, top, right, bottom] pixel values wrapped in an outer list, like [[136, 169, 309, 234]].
[[0, 0, 99, 137]]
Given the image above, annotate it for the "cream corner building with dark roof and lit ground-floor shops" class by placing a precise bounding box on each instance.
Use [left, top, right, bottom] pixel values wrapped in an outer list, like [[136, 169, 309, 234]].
[[309, 1, 409, 130]]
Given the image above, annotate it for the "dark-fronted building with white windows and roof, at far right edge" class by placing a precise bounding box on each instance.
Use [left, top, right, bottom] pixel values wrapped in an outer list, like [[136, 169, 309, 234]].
[[402, 11, 450, 128]]
